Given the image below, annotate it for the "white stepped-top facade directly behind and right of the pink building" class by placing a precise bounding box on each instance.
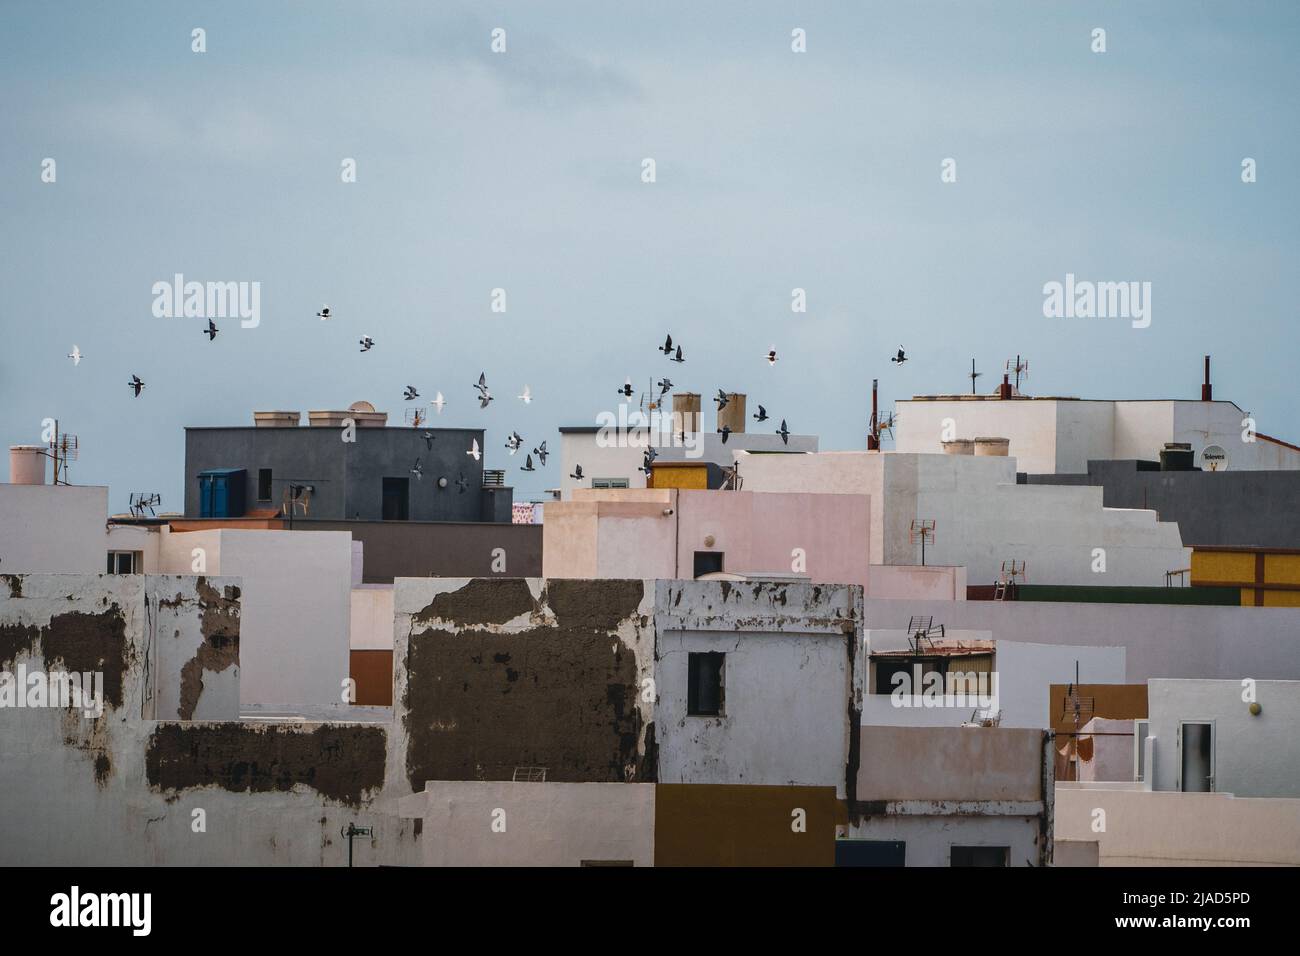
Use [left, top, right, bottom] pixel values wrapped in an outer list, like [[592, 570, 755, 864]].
[[737, 451, 1191, 587]]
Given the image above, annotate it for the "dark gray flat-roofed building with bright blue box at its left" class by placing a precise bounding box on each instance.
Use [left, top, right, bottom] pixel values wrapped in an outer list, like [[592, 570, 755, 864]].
[[185, 402, 514, 523]]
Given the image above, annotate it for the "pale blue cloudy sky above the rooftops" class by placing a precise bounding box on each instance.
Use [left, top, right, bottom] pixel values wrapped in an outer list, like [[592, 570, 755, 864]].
[[0, 0, 1300, 510]]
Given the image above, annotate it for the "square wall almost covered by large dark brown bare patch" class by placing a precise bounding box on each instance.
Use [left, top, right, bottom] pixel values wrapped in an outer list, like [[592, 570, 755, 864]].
[[394, 578, 655, 791]]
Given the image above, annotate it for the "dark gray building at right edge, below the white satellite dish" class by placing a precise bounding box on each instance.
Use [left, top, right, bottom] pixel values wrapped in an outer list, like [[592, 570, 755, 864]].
[[1017, 460, 1300, 548]]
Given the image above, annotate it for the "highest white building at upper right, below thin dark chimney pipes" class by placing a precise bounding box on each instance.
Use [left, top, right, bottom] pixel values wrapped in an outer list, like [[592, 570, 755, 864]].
[[894, 395, 1300, 475]]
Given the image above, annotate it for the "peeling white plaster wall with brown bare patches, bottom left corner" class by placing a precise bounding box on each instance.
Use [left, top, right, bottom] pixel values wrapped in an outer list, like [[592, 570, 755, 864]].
[[0, 575, 419, 866]]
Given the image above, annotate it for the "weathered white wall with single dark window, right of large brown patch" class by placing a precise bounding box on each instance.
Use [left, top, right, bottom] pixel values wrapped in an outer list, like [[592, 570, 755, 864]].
[[655, 581, 863, 797]]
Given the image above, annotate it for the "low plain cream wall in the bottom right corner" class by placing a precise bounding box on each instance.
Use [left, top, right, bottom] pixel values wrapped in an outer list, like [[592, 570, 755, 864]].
[[1056, 783, 1300, 866]]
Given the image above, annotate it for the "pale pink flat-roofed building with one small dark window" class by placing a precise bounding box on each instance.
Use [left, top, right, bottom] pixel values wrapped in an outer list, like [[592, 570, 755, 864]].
[[542, 488, 871, 591]]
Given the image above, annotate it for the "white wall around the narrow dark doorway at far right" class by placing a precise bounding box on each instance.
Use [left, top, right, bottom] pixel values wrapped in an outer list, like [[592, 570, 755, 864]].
[[1147, 680, 1300, 797]]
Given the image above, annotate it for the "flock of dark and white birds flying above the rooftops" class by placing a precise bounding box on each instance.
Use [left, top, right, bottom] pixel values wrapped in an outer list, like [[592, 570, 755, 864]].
[[68, 306, 907, 493]]
